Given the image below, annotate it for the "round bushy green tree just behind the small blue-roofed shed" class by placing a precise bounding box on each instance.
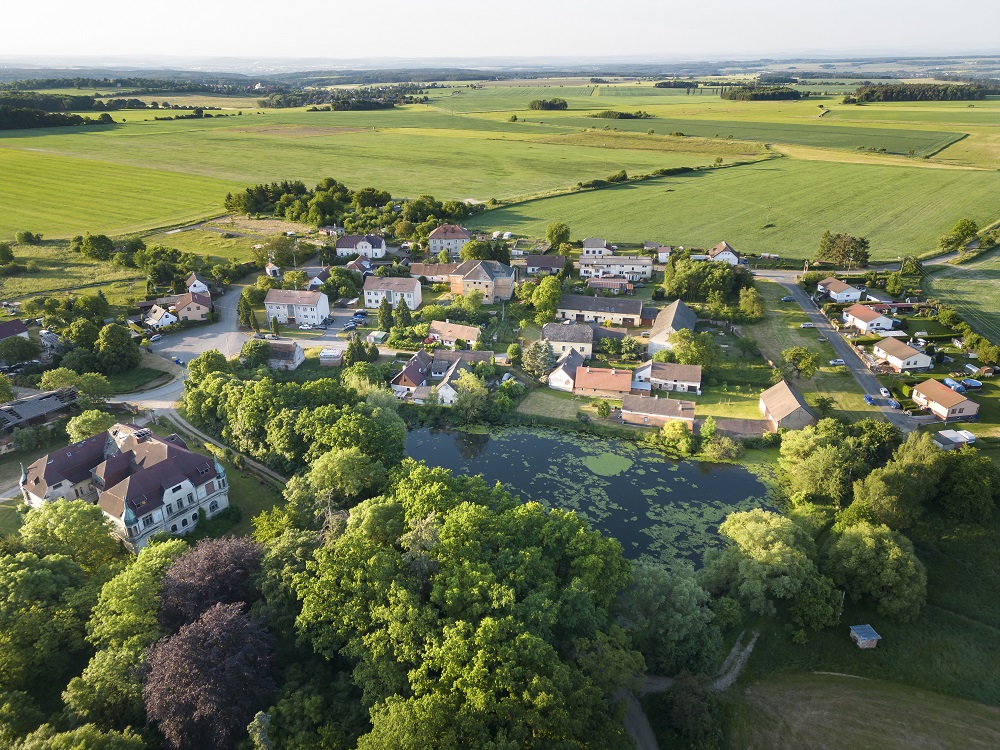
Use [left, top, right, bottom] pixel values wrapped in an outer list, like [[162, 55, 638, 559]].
[[829, 522, 927, 622]]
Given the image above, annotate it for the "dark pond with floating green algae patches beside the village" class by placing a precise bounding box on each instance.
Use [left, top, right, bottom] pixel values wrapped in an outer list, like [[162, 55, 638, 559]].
[[406, 427, 770, 566]]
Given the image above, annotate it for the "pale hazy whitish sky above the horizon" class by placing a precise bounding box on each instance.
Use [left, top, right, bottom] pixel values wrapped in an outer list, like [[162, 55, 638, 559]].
[[0, 0, 1000, 64]]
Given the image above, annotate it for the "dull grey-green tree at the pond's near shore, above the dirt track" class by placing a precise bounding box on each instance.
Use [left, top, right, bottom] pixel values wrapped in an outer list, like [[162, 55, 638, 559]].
[[620, 562, 722, 675]]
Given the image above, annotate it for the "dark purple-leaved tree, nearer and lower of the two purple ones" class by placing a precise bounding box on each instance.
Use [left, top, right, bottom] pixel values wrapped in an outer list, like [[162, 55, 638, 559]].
[[143, 604, 275, 750]]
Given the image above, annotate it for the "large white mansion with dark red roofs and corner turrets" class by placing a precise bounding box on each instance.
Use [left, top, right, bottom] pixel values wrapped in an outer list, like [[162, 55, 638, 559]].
[[20, 424, 229, 550]]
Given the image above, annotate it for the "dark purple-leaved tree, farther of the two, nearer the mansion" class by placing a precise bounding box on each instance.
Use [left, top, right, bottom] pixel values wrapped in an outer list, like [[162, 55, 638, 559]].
[[160, 537, 262, 630]]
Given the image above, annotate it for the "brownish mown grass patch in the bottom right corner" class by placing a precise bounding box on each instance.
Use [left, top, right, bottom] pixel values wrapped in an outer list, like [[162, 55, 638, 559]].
[[730, 672, 1000, 750]]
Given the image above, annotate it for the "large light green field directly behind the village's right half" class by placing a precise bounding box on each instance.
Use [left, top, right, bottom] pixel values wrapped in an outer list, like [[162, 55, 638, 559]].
[[472, 158, 1000, 260]]
